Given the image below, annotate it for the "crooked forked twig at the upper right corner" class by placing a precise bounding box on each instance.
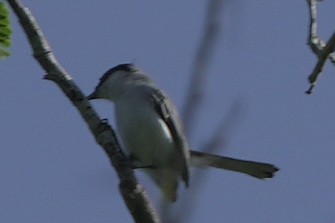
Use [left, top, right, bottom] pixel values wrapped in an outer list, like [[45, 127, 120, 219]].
[[306, 0, 335, 94]]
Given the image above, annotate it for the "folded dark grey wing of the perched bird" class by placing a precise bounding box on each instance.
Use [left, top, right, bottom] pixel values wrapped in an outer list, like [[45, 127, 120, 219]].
[[150, 89, 190, 186]]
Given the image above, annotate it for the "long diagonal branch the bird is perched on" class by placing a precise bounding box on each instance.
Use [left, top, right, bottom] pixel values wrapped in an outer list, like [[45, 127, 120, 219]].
[[7, 0, 160, 223]]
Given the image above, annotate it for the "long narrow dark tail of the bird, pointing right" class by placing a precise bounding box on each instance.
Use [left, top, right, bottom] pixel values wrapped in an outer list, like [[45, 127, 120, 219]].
[[190, 150, 279, 179]]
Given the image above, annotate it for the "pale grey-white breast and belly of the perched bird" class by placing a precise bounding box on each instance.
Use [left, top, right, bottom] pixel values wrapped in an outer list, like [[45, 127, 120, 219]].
[[115, 100, 175, 166]]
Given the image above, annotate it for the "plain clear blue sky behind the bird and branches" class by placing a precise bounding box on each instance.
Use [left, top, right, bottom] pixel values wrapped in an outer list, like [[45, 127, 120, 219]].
[[0, 0, 335, 223]]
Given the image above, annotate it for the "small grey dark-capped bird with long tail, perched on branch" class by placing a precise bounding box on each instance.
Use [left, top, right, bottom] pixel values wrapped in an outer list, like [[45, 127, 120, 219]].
[[87, 64, 278, 202]]
